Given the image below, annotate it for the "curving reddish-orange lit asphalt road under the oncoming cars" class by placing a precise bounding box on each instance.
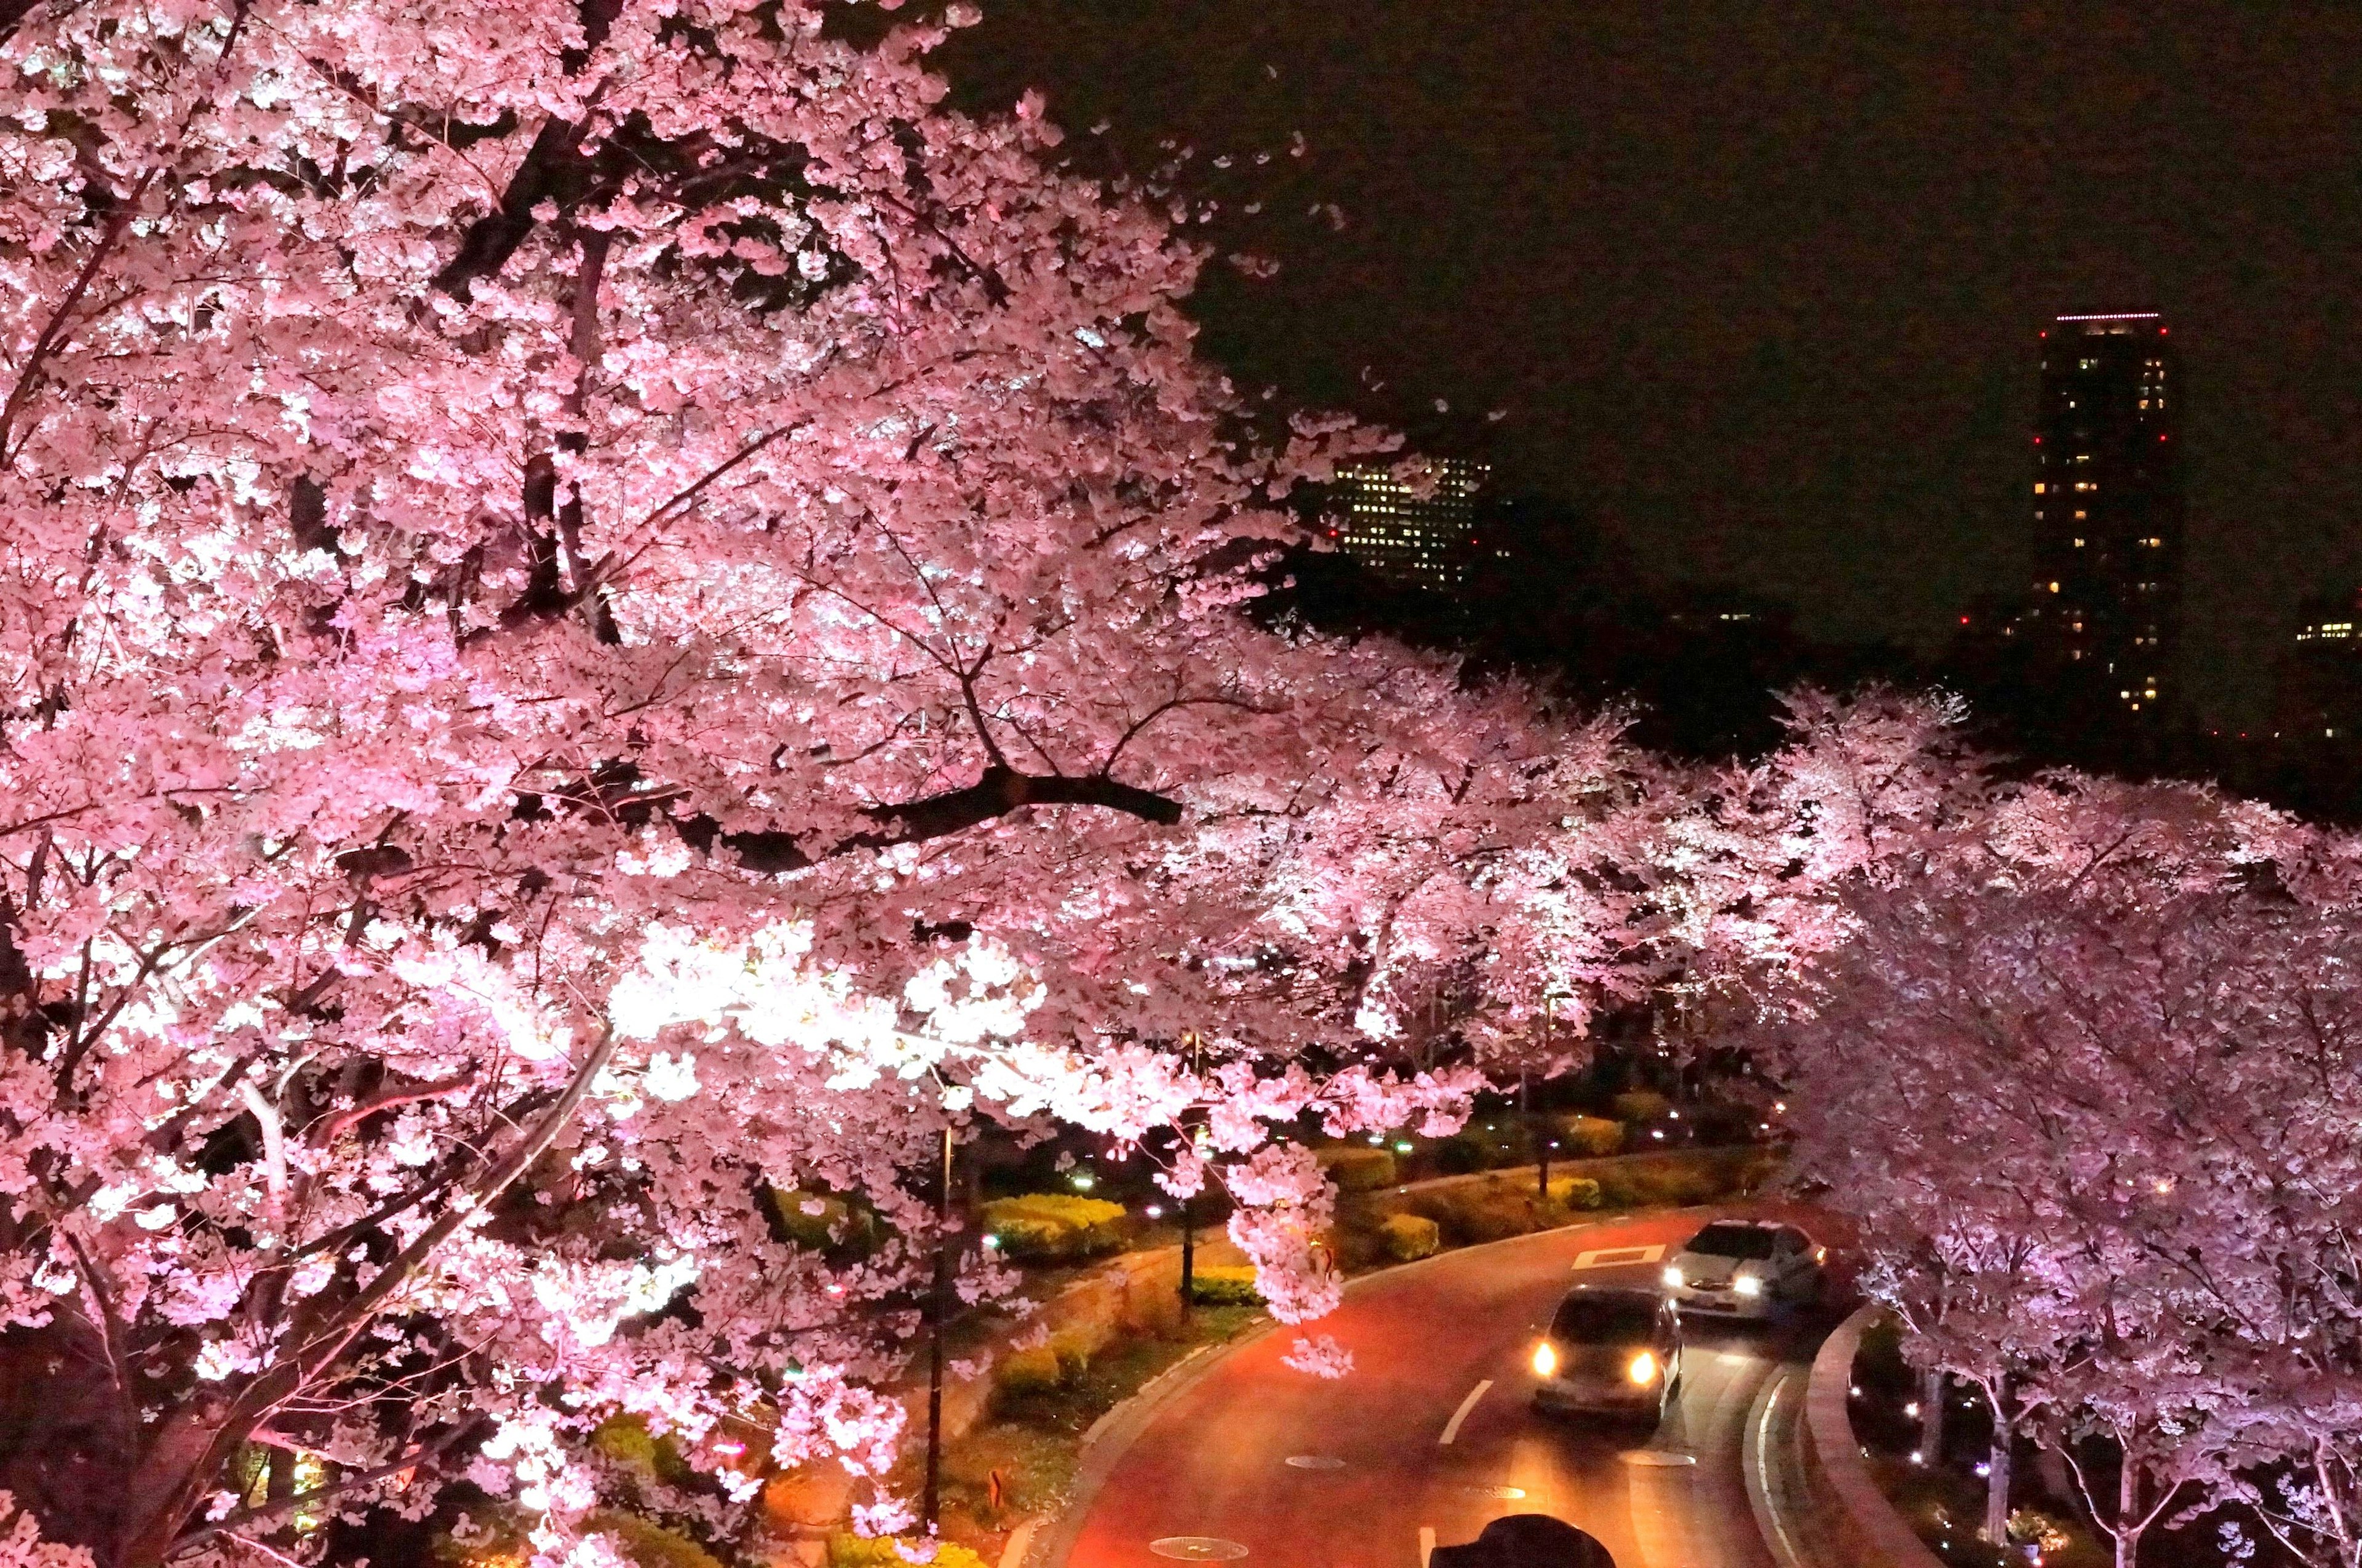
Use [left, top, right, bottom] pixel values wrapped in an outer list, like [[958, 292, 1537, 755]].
[[1049, 1204, 1831, 1568]]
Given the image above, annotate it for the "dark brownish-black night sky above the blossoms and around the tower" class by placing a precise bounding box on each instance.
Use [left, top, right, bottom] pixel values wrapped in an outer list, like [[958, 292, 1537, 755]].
[[950, 0, 2362, 723]]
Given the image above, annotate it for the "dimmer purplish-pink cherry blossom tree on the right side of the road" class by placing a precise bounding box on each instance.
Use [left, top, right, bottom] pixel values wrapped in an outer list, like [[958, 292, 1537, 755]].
[[1769, 703, 2362, 1563]]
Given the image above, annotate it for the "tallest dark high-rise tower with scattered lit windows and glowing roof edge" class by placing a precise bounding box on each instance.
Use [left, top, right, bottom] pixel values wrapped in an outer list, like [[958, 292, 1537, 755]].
[[2024, 314, 2185, 727]]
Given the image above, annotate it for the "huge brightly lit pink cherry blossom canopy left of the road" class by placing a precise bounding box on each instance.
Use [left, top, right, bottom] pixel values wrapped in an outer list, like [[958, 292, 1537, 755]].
[[0, 0, 1677, 1568]]
